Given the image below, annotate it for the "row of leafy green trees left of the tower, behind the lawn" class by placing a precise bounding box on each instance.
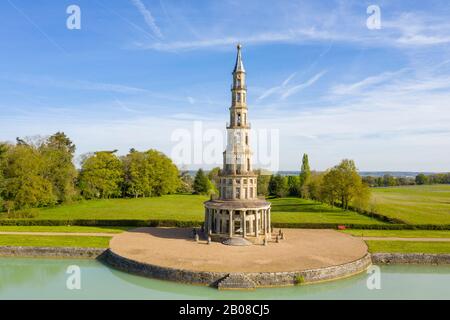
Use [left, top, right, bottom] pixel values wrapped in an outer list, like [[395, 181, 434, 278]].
[[0, 132, 181, 212]]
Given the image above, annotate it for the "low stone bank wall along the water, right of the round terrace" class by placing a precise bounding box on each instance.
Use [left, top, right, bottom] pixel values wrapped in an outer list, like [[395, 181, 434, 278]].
[[372, 253, 450, 264]]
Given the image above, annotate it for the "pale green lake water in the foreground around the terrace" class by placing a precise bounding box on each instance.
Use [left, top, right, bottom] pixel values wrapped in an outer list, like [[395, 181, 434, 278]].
[[0, 258, 450, 299]]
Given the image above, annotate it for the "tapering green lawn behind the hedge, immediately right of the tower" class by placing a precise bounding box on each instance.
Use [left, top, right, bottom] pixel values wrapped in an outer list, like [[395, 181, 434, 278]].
[[269, 198, 383, 224]]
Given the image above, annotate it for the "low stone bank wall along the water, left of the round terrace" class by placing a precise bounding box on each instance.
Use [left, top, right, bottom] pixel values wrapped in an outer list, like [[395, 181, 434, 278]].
[[0, 246, 106, 259]]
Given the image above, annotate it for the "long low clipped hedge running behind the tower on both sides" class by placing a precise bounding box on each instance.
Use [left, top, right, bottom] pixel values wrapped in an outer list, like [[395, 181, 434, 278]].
[[0, 219, 450, 230]]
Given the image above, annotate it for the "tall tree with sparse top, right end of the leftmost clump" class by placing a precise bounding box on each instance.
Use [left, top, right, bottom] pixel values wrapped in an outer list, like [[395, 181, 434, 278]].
[[39, 132, 77, 202]]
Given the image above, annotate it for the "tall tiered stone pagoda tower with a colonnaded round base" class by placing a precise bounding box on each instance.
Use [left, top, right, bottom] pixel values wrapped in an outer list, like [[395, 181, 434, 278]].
[[204, 44, 271, 245]]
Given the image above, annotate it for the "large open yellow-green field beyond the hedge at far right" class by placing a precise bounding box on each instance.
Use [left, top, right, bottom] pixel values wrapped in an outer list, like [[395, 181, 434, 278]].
[[371, 185, 450, 224]]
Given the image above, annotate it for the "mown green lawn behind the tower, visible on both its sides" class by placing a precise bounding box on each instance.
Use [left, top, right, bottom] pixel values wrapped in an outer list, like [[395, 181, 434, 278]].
[[4, 195, 381, 224]]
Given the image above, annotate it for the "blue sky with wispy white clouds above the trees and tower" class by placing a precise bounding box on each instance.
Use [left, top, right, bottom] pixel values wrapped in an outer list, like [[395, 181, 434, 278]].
[[0, 0, 450, 171]]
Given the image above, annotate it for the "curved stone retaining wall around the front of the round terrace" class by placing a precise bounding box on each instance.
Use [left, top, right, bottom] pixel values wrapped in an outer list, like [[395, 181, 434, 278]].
[[99, 249, 372, 289]]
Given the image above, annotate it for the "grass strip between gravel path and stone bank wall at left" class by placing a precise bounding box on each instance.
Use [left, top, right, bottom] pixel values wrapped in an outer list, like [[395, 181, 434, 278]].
[[0, 235, 111, 248]]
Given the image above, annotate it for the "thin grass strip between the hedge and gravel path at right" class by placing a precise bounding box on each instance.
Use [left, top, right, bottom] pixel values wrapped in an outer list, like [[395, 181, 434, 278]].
[[340, 229, 450, 238]]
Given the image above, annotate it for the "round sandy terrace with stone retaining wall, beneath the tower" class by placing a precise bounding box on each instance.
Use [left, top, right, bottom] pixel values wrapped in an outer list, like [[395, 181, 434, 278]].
[[101, 227, 371, 289]]
